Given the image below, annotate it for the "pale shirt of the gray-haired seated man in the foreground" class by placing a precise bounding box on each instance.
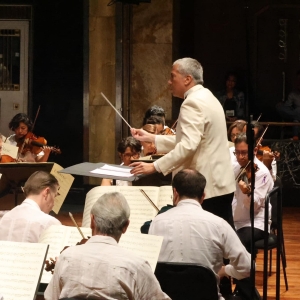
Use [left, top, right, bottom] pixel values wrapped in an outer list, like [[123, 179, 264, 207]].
[[45, 235, 170, 300]]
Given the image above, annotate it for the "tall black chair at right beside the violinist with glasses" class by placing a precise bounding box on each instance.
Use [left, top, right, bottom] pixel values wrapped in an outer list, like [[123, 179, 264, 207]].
[[255, 177, 289, 300]]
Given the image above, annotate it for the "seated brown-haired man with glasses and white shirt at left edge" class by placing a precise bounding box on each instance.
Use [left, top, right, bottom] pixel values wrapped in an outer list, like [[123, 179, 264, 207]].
[[0, 171, 61, 243]]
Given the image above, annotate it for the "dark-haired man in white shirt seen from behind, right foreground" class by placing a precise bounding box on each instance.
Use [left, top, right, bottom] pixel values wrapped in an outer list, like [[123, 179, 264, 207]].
[[149, 169, 251, 299]]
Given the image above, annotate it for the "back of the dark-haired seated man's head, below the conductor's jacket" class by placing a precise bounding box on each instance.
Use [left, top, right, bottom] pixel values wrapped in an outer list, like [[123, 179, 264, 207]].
[[172, 169, 206, 199]]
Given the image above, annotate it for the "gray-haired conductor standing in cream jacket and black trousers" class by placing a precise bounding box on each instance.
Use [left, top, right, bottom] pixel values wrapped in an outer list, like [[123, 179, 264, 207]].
[[131, 58, 235, 226]]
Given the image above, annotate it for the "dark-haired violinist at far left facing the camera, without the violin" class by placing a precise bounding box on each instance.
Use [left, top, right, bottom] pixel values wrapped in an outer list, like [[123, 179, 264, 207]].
[[5, 113, 51, 162]]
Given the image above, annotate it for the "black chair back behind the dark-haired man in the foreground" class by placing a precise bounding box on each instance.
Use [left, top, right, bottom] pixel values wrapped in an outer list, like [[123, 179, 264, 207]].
[[154, 262, 219, 300]]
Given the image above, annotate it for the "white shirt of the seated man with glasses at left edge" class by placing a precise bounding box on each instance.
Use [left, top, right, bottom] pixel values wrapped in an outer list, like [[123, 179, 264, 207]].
[[0, 198, 61, 243]]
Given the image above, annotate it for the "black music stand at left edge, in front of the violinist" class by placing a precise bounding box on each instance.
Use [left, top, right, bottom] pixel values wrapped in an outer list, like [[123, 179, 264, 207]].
[[0, 162, 54, 206]]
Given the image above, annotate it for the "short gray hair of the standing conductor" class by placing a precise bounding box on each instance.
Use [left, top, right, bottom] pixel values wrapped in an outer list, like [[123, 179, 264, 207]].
[[173, 57, 203, 84]]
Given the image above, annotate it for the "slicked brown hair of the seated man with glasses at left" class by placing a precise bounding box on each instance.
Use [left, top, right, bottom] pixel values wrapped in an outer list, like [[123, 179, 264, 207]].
[[23, 171, 58, 197]]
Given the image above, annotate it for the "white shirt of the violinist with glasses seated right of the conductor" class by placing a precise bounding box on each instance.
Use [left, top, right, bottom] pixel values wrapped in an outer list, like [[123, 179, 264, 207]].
[[232, 157, 274, 230]]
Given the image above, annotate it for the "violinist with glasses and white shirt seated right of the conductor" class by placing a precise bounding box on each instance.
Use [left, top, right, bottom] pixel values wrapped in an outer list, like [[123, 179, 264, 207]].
[[232, 133, 274, 253]]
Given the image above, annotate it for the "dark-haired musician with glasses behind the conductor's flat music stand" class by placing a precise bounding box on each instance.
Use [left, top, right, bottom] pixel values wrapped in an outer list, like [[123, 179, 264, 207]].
[[101, 136, 142, 186]]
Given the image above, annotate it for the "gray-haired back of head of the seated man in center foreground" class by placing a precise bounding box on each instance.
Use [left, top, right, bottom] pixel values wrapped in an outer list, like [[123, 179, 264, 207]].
[[91, 193, 130, 237]]
